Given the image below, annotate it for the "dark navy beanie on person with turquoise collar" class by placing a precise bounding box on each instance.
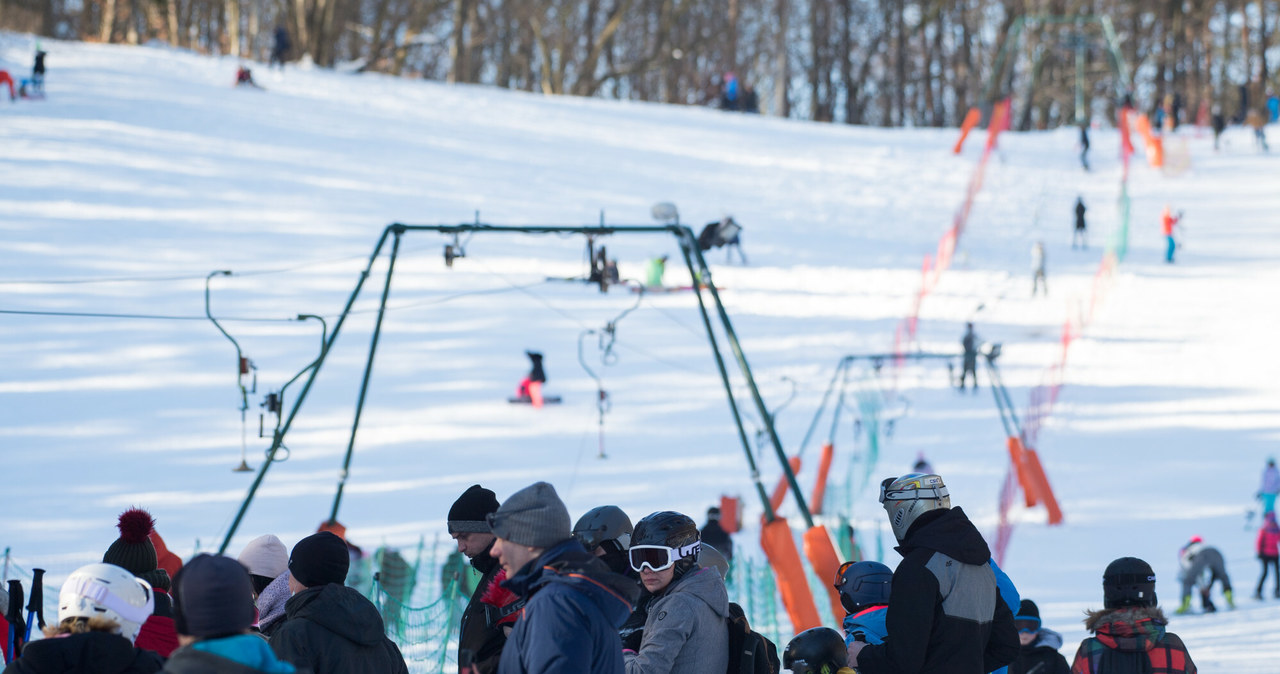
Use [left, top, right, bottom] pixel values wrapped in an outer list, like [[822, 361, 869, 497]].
[[173, 554, 256, 638]]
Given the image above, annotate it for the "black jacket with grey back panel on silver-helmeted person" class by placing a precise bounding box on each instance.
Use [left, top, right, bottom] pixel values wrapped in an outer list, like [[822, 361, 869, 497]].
[[858, 508, 1019, 674]]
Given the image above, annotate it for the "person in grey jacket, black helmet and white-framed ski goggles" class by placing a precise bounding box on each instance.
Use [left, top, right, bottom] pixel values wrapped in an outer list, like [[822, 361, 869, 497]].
[[622, 510, 728, 674]]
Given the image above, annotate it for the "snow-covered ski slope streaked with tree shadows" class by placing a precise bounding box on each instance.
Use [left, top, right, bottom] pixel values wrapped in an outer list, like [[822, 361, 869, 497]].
[[0, 35, 1280, 671]]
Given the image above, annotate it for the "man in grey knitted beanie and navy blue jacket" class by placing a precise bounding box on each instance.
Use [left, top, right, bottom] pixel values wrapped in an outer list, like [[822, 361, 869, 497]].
[[488, 482, 636, 674]]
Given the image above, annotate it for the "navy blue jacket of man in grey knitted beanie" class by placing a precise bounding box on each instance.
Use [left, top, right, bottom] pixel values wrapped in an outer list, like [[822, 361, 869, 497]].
[[498, 538, 636, 674]]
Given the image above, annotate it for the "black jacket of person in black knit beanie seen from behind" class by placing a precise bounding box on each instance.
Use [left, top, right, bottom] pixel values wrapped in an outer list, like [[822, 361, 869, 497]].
[[271, 583, 408, 674]]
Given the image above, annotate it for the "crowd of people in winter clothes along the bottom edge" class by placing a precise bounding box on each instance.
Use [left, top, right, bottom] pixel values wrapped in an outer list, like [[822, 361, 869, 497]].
[[12, 468, 1249, 674]]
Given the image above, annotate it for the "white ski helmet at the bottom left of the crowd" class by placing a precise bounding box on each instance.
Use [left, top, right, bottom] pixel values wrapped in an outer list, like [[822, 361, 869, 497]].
[[58, 564, 155, 643]]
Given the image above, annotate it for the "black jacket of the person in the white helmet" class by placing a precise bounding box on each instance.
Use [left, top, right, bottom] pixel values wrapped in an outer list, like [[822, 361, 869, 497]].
[[4, 632, 164, 674]]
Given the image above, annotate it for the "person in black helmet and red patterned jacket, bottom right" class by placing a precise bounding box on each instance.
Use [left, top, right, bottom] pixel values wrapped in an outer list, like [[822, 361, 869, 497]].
[[1071, 558, 1196, 674]]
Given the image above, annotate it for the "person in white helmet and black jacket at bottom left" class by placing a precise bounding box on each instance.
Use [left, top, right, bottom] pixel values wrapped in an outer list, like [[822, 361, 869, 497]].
[[4, 564, 164, 674]]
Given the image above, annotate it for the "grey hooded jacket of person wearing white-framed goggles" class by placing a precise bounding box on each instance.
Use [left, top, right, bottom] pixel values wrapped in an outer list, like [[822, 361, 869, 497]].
[[622, 567, 728, 674]]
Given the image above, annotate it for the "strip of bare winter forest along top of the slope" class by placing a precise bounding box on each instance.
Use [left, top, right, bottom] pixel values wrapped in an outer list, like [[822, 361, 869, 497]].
[[0, 0, 1280, 129]]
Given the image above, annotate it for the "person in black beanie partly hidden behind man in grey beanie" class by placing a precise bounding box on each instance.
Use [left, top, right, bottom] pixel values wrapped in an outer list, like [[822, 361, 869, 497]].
[[448, 485, 524, 674]]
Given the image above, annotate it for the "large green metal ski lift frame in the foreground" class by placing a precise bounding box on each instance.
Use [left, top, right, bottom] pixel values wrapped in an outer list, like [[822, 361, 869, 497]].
[[218, 221, 813, 554]]
